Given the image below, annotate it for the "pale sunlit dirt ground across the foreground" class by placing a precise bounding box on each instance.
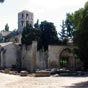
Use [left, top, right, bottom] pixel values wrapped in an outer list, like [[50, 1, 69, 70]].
[[0, 73, 88, 88]]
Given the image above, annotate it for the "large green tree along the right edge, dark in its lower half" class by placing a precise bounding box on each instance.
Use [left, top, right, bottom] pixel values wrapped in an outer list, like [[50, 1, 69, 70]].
[[73, 2, 88, 69]]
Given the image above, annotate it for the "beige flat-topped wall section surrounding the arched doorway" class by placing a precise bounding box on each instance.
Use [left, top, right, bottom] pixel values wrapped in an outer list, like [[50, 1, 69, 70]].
[[48, 46, 74, 68]]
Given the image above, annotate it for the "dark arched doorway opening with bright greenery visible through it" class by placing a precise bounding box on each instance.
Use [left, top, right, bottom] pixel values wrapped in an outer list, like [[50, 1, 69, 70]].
[[59, 48, 71, 69]]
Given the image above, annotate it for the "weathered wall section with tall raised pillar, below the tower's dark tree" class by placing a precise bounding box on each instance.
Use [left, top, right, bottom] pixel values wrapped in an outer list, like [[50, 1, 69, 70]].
[[21, 41, 37, 72]]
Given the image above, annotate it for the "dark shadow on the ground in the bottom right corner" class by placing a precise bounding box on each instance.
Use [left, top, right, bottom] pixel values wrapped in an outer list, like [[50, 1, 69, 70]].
[[65, 81, 88, 88]]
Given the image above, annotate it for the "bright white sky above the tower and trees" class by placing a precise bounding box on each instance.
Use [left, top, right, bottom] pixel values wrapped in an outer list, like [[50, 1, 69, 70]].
[[0, 0, 87, 32]]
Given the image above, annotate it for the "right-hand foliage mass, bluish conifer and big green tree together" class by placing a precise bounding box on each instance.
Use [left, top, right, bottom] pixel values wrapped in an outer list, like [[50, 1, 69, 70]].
[[60, 2, 88, 69]]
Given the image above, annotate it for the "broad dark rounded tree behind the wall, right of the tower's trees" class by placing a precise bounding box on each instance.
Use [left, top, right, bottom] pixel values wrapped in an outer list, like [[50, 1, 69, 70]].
[[40, 21, 60, 51]]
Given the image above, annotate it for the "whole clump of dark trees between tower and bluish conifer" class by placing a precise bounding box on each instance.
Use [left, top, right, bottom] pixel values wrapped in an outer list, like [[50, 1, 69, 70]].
[[21, 21, 60, 51]]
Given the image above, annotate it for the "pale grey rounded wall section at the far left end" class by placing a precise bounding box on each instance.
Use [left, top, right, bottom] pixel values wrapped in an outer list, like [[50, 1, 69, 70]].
[[0, 44, 17, 68]]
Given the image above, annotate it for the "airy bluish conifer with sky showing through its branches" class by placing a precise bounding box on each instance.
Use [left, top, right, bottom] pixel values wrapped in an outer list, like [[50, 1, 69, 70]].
[[59, 13, 74, 45]]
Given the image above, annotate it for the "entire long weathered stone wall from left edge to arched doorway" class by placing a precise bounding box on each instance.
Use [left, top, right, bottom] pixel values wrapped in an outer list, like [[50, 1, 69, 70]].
[[0, 41, 82, 72]]
